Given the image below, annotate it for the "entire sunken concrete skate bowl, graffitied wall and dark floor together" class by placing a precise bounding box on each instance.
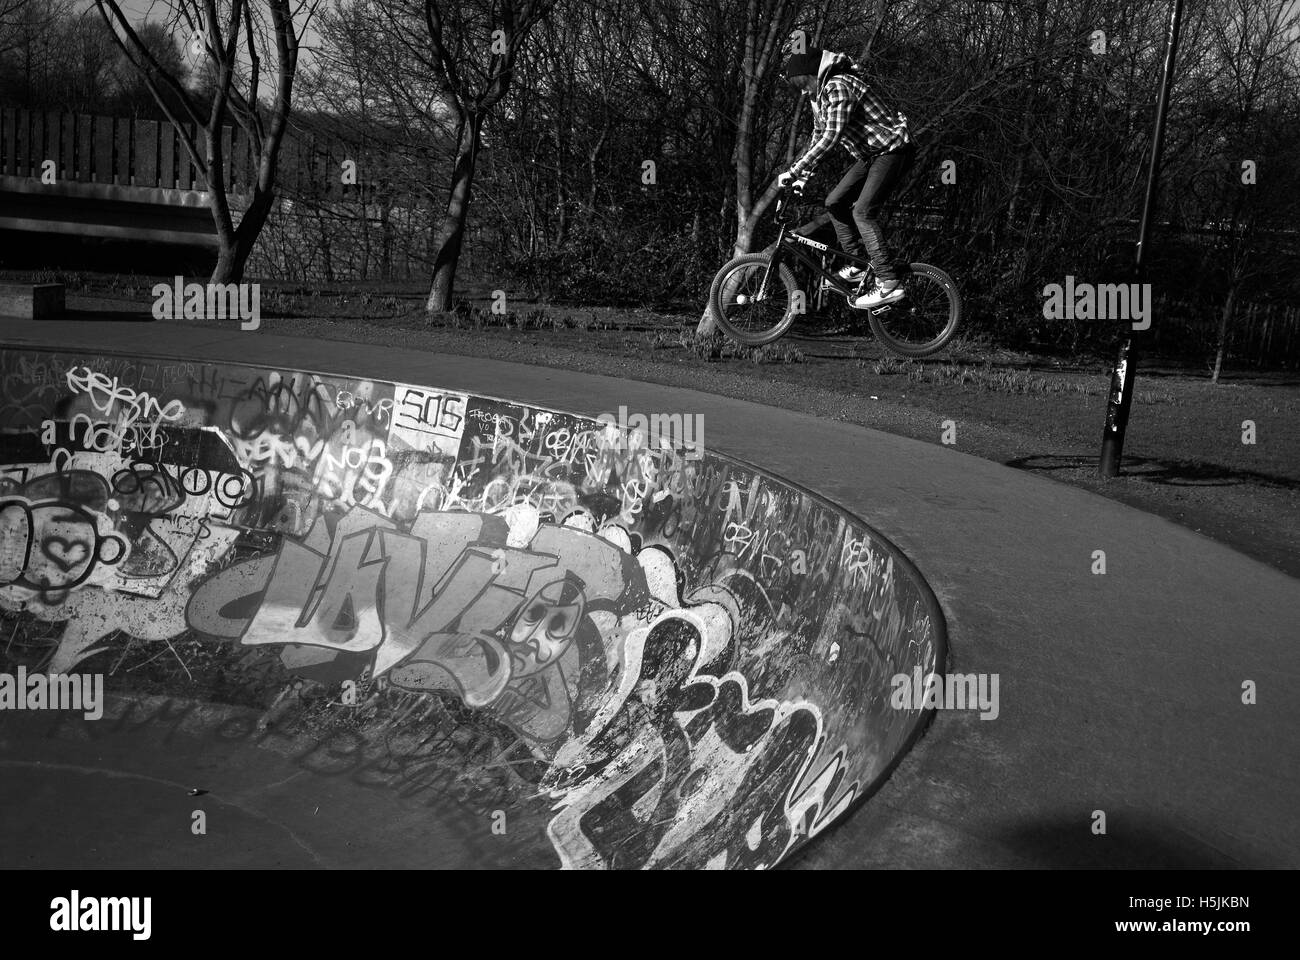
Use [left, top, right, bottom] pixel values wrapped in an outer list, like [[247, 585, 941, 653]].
[[0, 349, 945, 869]]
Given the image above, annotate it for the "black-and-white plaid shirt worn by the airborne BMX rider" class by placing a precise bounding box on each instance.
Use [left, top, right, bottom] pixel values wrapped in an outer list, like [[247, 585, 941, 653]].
[[790, 69, 911, 180]]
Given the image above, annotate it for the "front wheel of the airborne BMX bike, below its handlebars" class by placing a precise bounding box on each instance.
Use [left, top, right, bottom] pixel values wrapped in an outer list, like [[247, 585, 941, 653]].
[[709, 254, 802, 346]]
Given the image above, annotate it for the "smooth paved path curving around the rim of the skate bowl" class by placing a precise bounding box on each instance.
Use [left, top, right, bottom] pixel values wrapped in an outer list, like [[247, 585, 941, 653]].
[[0, 321, 1300, 868]]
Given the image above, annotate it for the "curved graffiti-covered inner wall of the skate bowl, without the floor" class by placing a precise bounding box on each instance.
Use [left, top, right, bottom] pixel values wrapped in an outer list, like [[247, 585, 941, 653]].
[[0, 349, 944, 868]]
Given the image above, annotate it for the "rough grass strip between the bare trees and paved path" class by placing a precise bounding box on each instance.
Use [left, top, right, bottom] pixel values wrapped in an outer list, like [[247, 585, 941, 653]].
[[10, 265, 1300, 575]]
